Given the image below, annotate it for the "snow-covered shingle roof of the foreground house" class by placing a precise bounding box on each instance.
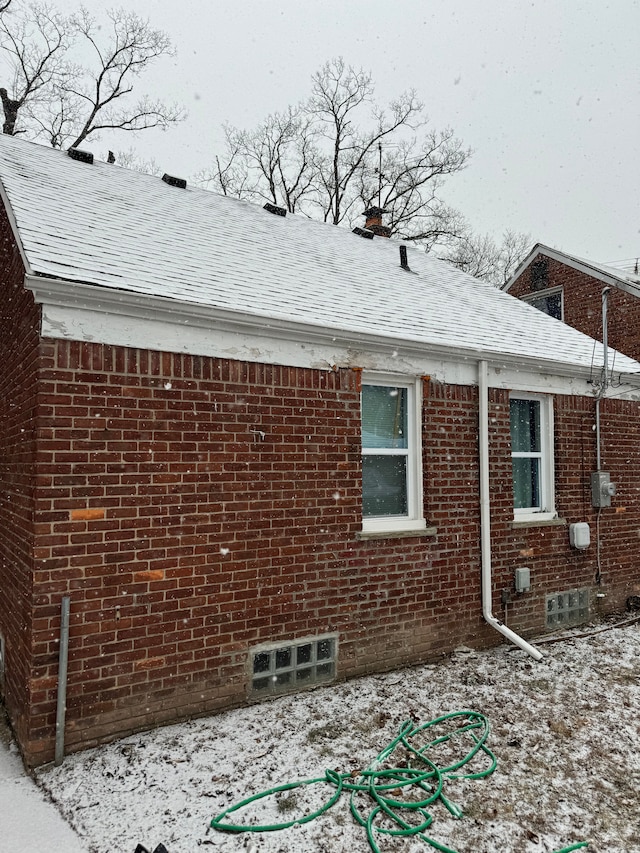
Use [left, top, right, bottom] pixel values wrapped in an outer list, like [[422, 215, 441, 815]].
[[0, 135, 640, 373]]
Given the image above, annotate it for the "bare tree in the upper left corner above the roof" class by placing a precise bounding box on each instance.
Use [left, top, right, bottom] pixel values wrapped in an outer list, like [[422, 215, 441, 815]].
[[0, 4, 183, 148]]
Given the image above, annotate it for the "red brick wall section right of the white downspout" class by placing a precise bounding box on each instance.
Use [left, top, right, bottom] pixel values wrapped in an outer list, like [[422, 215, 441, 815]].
[[490, 391, 640, 635]]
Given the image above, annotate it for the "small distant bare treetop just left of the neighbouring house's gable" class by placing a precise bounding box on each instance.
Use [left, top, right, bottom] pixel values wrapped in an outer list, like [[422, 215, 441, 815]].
[[445, 231, 531, 287]]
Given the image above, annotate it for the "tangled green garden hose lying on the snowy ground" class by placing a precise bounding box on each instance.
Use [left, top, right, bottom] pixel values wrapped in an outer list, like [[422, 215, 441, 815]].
[[211, 711, 588, 853]]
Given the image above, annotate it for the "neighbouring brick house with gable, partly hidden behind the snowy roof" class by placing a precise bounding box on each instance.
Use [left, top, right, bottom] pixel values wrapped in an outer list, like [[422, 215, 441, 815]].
[[503, 243, 640, 360]]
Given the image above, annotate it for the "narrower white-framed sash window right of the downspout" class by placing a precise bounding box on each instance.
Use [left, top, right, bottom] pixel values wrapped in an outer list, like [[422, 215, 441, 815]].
[[510, 396, 556, 521]]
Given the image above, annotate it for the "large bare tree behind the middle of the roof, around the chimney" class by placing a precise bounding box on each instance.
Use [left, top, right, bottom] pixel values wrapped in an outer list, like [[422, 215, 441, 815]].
[[200, 58, 470, 246]]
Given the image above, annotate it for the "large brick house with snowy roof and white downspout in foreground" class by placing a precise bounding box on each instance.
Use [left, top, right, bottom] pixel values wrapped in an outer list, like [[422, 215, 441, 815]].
[[0, 136, 640, 764]]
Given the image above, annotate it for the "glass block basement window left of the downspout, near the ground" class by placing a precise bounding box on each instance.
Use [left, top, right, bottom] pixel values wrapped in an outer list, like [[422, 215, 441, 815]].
[[251, 636, 337, 696]]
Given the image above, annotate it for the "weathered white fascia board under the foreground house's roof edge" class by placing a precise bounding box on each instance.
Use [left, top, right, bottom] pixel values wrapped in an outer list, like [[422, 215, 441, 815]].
[[25, 276, 640, 393]]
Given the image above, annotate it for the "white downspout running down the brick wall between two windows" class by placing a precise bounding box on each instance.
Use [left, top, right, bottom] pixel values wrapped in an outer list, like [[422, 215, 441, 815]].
[[478, 361, 542, 661]]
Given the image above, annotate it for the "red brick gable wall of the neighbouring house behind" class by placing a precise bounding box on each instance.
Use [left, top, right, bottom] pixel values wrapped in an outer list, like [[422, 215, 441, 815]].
[[509, 253, 640, 360]]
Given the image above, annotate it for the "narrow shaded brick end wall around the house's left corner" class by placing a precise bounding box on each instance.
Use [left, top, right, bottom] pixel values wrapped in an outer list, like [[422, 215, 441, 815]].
[[0, 211, 39, 738]]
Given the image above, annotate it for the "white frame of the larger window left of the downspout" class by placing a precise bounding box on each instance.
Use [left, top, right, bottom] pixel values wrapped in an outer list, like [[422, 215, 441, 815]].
[[361, 373, 427, 534]]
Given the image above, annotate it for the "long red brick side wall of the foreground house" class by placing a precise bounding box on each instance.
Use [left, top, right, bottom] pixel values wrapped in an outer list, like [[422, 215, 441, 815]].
[[10, 341, 640, 762]]
